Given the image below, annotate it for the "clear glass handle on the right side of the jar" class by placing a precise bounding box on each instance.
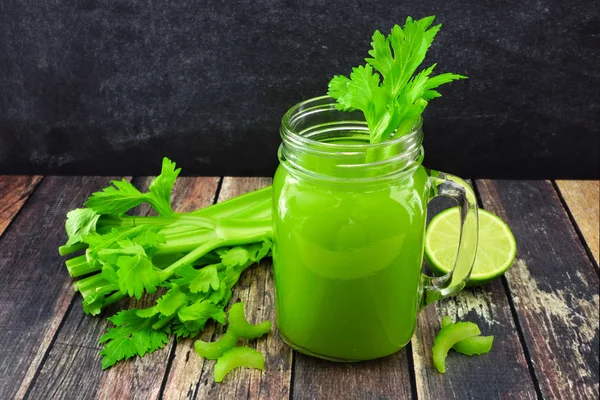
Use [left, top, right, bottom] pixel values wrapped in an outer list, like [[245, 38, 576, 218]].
[[422, 170, 479, 306]]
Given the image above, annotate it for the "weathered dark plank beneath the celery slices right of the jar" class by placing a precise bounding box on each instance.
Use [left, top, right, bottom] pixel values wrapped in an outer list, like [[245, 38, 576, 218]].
[[412, 193, 537, 399]]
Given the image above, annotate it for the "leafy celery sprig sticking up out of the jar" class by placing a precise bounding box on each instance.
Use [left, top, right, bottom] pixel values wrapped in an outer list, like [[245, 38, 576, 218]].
[[328, 16, 466, 143]]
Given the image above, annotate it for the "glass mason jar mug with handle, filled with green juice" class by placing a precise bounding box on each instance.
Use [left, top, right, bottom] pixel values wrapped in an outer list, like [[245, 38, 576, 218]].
[[273, 96, 478, 361]]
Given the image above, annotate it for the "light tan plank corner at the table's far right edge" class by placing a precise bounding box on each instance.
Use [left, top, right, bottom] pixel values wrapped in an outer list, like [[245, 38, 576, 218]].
[[556, 181, 600, 266]]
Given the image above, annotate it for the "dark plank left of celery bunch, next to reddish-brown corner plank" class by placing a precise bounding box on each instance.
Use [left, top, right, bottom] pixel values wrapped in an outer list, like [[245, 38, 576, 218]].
[[0, 177, 122, 399]]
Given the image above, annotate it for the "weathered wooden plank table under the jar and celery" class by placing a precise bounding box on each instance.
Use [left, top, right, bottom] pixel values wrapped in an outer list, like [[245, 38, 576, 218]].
[[0, 176, 599, 399]]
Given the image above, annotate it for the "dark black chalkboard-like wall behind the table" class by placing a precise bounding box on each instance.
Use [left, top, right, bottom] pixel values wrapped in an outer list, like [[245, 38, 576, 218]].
[[0, 0, 600, 179]]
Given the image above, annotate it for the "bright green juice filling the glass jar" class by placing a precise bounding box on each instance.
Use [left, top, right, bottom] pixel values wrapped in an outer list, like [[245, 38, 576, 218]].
[[273, 162, 428, 360]]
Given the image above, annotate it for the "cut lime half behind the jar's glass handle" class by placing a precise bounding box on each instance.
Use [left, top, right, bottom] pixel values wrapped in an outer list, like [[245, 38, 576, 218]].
[[425, 207, 517, 286]]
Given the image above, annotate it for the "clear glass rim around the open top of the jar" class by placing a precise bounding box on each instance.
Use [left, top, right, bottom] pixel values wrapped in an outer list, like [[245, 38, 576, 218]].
[[281, 95, 423, 148]]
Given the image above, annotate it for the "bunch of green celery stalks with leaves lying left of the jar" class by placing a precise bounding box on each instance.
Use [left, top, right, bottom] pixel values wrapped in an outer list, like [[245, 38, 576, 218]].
[[59, 158, 272, 369]]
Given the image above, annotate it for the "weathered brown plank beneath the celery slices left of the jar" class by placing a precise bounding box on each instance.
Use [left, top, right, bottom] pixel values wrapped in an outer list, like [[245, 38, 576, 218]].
[[163, 177, 292, 399]]
